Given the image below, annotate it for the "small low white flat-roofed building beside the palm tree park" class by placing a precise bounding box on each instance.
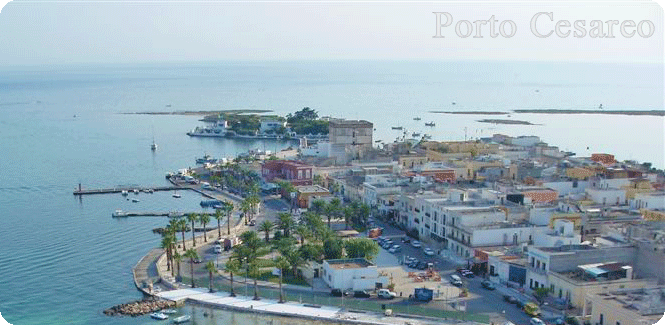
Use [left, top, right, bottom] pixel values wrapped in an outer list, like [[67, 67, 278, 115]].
[[322, 258, 388, 290]]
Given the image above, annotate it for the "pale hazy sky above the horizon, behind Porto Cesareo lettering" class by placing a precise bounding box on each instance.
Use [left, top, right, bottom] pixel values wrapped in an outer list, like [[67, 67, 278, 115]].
[[0, 0, 663, 66]]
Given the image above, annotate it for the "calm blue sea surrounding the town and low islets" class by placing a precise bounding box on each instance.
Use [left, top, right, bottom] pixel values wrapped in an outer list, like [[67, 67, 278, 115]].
[[0, 61, 665, 325]]
